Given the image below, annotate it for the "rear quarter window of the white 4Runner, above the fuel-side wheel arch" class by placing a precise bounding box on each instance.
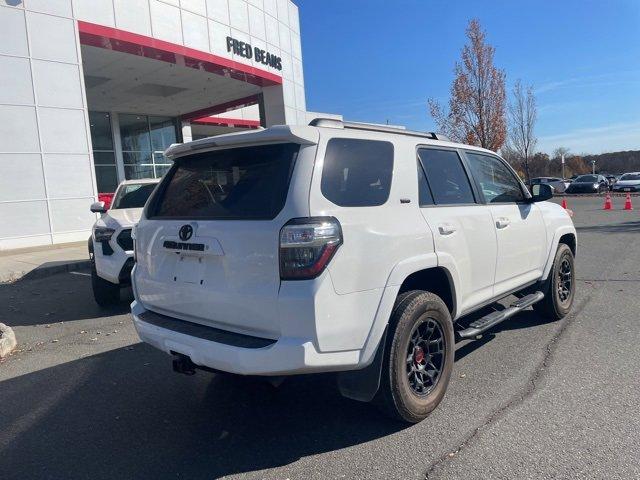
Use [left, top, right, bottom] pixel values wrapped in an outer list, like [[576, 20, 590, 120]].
[[321, 138, 393, 207]]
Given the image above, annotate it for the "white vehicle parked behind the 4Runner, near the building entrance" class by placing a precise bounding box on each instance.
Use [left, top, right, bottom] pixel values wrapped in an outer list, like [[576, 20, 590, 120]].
[[88, 178, 160, 305]]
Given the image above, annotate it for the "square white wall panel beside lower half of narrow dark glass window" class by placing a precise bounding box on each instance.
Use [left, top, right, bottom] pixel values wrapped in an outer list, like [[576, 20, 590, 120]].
[[44, 154, 93, 198]]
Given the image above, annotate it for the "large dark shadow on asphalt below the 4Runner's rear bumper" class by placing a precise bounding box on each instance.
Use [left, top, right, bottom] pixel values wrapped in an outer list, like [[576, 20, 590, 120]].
[[0, 346, 404, 480]]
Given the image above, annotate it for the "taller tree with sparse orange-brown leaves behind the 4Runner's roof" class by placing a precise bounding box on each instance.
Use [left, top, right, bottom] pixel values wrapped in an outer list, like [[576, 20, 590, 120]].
[[429, 19, 507, 151]]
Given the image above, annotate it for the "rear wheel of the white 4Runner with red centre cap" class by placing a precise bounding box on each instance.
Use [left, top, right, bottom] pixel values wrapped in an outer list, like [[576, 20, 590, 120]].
[[374, 290, 454, 423]]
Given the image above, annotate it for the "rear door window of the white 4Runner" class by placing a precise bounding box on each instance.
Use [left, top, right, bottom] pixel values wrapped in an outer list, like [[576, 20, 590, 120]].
[[418, 148, 475, 205]]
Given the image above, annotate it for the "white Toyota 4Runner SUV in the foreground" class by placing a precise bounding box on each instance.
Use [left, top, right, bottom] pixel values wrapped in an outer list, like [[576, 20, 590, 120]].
[[131, 119, 576, 422]]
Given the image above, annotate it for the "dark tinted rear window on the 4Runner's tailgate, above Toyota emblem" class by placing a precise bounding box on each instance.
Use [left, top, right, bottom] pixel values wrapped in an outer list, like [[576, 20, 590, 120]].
[[152, 143, 300, 220]]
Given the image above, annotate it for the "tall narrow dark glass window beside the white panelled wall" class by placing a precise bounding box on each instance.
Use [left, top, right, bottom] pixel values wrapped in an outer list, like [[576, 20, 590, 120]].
[[89, 112, 118, 193]]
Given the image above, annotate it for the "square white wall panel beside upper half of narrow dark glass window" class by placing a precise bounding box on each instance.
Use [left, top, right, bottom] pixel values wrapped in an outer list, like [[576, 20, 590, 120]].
[[38, 107, 88, 153]]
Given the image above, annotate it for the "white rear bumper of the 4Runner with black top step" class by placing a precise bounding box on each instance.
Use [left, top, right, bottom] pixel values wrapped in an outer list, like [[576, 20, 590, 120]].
[[131, 301, 361, 375]]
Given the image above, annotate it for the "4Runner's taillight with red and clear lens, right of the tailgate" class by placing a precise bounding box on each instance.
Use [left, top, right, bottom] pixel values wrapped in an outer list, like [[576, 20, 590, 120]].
[[280, 217, 342, 280]]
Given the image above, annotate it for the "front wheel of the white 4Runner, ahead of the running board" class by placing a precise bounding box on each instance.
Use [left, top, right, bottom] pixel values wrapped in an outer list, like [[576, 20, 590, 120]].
[[533, 243, 576, 320]]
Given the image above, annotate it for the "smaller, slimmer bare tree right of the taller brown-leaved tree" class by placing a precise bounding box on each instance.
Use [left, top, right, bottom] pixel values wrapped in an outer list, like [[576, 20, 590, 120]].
[[507, 80, 538, 183]]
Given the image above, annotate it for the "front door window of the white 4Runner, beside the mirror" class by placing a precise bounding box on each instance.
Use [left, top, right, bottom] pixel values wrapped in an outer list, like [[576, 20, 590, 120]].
[[465, 151, 524, 203]]
